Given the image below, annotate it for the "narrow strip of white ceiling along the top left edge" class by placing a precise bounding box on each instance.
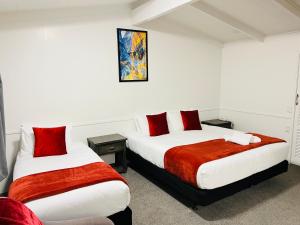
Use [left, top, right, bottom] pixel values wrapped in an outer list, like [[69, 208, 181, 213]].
[[0, 0, 137, 12]]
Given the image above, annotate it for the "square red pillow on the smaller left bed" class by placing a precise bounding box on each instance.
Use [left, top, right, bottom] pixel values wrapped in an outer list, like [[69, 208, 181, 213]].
[[32, 126, 67, 157]]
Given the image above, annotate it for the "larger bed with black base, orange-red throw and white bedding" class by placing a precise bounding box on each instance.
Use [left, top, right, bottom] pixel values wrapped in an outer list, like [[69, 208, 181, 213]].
[[126, 125, 289, 206]]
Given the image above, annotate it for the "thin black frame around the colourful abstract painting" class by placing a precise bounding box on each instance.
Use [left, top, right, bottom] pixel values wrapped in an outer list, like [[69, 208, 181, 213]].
[[117, 28, 149, 82]]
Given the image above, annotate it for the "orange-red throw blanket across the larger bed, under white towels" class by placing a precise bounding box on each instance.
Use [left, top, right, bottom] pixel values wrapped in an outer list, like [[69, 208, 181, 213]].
[[164, 133, 285, 187]]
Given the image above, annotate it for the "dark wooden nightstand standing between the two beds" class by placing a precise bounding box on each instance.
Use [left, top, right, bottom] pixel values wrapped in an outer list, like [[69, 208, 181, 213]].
[[87, 134, 127, 173]]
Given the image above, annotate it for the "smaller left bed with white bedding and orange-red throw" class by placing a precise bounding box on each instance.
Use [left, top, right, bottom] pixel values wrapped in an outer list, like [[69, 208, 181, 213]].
[[9, 143, 131, 224]]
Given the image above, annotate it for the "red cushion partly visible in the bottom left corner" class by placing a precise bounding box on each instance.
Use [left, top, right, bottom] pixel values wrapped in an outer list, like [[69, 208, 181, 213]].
[[0, 198, 43, 225]]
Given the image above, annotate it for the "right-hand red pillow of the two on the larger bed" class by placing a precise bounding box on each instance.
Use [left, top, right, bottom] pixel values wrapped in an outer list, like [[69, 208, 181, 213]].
[[180, 110, 202, 130]]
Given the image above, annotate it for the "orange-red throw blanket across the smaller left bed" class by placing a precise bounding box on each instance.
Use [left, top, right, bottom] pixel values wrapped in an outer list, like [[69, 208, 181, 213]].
[[8, 162, 127, 203]]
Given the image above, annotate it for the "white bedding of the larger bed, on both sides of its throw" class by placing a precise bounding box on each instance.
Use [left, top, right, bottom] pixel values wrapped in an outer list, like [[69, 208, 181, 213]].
[[124, 125, 289, 189]]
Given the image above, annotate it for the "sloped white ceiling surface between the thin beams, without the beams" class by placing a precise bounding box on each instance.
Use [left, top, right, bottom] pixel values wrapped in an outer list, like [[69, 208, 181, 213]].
[[163, 0, 300, 42]]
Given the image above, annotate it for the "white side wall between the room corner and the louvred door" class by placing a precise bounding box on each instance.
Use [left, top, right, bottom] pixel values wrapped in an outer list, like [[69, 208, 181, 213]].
[[220, 33, 300, 162]]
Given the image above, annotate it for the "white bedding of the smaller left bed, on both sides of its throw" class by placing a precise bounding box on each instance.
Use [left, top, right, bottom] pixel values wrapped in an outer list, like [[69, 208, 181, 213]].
[[13, 143, 130, 221]]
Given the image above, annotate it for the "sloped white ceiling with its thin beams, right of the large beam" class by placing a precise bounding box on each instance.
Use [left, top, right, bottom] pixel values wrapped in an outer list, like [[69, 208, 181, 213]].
[[135, 0, 300, 43]]
